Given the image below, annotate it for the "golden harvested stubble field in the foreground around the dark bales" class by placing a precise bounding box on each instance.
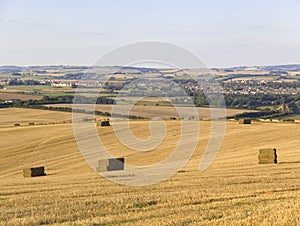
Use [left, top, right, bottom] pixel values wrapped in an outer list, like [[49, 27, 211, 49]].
[[0, 108, 300, 225]]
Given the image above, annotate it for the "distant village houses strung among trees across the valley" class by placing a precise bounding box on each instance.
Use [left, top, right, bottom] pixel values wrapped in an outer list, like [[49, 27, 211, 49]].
[[0, 74, 300, 95]]
